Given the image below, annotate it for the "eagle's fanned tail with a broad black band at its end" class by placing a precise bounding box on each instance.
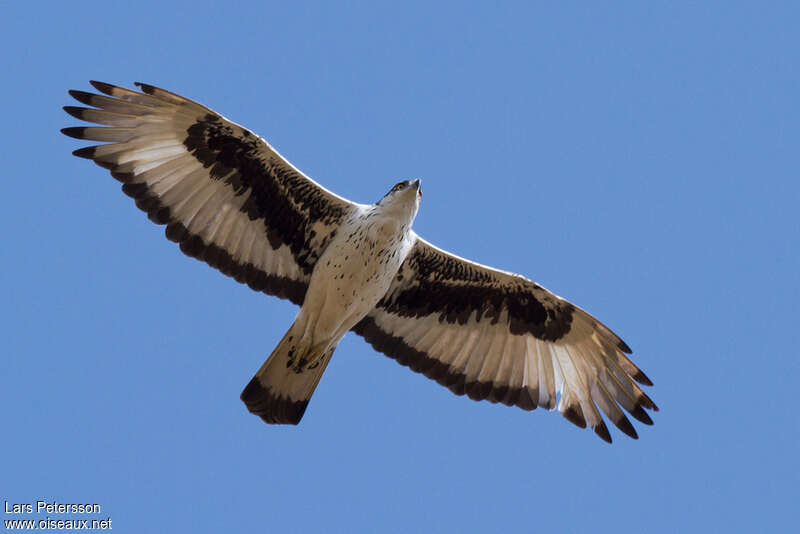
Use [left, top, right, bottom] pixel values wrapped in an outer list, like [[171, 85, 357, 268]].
[[241, 327, 336, 425]]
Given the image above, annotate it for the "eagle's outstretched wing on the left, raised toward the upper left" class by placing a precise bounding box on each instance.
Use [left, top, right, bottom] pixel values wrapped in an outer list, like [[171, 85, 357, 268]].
[[62, 81, 355, 305]]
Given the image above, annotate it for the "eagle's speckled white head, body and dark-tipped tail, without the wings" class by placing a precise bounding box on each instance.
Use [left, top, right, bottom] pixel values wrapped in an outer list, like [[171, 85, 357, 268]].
[[242, 193, 419, 424]]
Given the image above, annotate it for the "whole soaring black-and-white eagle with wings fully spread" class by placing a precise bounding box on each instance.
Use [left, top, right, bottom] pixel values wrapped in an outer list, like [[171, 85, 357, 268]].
[[61, 81, 658, 443]]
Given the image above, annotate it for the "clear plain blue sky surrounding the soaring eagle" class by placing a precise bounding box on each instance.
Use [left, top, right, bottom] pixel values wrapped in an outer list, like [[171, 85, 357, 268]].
[[0, 0, 800, 532]]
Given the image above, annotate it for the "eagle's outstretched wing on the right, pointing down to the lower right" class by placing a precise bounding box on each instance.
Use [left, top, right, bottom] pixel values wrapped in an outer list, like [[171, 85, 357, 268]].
[[353, 237, 658, 442]]
